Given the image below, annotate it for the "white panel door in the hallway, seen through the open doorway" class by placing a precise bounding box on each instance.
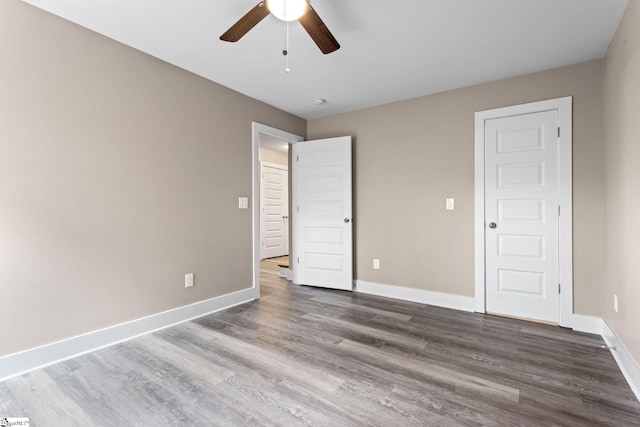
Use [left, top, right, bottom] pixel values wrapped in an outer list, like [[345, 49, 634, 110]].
[[260, 162, 289, 259]]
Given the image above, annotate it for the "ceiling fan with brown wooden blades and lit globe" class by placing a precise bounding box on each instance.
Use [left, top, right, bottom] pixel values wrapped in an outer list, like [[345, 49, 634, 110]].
[[220, 0, 340, 54]]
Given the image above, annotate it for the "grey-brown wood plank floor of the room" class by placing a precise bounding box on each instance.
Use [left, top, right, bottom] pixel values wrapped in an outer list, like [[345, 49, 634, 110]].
[[0, 259, 640, 427]]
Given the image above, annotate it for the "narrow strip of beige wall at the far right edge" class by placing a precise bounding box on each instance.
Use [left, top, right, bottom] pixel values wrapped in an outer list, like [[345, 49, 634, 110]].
[[603, 1, 640, 363]]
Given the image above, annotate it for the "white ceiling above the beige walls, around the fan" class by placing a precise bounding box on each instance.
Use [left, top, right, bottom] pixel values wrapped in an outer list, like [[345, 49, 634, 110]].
[[23, 0, 628, 119]]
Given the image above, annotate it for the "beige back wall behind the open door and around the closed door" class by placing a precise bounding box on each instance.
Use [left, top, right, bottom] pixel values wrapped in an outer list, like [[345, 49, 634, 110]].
[[307, 60, 604, 316]]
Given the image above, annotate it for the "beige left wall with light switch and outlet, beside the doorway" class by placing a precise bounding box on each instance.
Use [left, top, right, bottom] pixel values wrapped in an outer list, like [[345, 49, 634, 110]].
[[0, 0, 306, 356]]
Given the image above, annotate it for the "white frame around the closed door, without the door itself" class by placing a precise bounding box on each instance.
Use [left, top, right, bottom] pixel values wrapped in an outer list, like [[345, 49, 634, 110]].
[[474, 96, 574, 327]]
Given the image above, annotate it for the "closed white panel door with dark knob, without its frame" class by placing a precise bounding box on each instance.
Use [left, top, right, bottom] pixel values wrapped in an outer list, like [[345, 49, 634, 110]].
[[485, 110, 559, 323]]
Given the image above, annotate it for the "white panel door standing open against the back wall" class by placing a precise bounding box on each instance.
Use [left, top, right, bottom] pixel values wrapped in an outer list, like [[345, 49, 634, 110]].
[[290, 136, 353, 290]]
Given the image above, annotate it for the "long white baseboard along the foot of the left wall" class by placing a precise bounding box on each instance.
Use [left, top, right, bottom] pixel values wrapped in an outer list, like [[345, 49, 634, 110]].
[[0, 288, 255, 381]]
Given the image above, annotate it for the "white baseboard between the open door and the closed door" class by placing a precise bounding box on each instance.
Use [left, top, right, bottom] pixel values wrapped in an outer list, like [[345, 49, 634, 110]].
[[354, 280, 475, 312]]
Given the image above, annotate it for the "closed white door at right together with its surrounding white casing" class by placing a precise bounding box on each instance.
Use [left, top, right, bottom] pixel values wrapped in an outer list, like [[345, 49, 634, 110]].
[[475, 97, 575, 326]]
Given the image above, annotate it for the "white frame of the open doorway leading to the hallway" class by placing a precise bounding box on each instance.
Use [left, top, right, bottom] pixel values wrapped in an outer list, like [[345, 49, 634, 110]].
[[251, 122, 304, 299]]
